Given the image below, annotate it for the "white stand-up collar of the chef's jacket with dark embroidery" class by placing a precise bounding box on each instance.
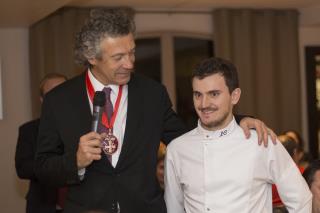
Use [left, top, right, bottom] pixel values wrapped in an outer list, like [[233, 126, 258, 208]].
[[197, 117, 237, 139]]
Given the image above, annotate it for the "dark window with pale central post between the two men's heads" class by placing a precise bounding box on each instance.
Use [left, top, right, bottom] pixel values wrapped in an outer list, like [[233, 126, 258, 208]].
[[136, 33, 214, 129]]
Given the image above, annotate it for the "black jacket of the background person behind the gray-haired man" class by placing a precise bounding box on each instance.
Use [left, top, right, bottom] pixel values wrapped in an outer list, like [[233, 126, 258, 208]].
[[15, 119, 57, 213]]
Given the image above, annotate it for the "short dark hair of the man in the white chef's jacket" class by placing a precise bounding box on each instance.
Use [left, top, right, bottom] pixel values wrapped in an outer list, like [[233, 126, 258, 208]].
[[192, 57, 239, 93]]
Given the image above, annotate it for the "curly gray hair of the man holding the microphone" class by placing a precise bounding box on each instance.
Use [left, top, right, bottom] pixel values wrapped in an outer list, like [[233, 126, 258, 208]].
[[75, 8, 136, 67]]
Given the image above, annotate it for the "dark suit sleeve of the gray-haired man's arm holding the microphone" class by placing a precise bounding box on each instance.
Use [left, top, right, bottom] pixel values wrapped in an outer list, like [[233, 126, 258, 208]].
[[35, 96, 80, 187]]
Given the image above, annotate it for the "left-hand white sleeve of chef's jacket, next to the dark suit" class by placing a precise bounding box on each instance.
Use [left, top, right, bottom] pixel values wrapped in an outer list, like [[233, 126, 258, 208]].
[[164, 146, 185, 213]]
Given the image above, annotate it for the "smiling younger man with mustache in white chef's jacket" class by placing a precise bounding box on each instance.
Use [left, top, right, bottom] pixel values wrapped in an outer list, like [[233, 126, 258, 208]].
[[165, 58, 312, 213]]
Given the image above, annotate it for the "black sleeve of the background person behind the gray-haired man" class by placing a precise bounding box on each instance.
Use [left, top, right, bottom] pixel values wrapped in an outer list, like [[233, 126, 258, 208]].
[[15, 123, 38, 179]]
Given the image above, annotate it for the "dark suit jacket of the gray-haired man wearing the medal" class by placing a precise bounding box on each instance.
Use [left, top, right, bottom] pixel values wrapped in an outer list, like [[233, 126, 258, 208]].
[[36, 74, 185, 213]]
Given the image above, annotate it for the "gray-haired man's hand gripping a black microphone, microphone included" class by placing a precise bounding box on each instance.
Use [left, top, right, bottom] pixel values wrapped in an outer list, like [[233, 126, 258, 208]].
[[77, 91, 106, 169]]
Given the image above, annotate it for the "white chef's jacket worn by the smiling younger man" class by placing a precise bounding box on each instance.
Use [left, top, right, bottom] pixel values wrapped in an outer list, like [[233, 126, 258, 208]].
[[165, 119, 312, 213]]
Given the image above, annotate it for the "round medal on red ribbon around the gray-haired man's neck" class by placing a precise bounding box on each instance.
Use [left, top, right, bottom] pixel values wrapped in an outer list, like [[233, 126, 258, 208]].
[[86, 70, 122, 155]]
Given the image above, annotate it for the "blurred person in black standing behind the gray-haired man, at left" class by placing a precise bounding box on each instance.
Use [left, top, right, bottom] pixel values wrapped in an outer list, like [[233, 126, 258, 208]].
[[15, 73, 67, 213]]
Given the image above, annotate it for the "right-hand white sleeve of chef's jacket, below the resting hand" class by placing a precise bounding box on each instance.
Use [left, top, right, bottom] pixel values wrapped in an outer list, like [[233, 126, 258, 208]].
[[269, 142, 312, 213]]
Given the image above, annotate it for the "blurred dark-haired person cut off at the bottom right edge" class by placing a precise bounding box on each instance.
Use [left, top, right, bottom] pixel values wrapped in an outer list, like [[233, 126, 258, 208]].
[[303, 159, 320, 213]]
